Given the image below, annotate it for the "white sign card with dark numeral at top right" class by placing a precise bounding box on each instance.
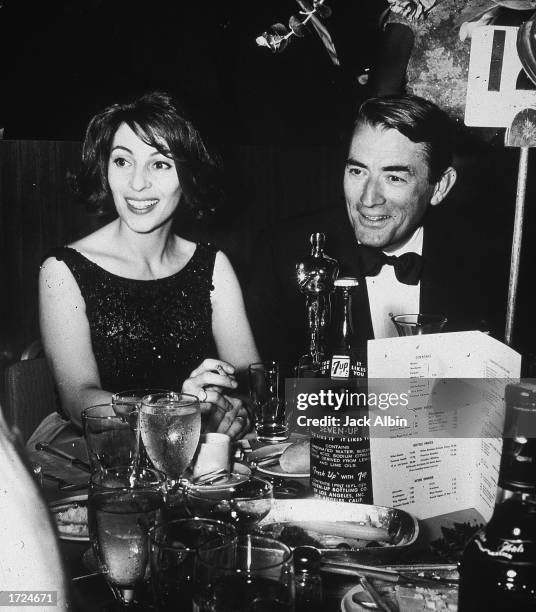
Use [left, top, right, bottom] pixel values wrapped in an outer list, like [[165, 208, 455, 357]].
[[465, 26, 536, 127]]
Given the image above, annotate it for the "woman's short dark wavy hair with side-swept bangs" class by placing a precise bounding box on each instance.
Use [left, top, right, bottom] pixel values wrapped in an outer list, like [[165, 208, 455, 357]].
[[72, 92, 221, 216]]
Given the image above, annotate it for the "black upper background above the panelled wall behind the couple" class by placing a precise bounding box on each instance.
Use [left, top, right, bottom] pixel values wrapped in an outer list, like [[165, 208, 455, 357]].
[[0, 0, 387, 144]]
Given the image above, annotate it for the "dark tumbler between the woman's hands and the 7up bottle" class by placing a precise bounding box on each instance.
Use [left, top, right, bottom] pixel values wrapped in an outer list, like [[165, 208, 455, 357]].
[[248, 361, 294, 442]]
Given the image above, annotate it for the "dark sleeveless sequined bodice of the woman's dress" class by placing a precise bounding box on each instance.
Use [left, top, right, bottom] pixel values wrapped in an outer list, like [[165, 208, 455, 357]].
[[49, 244, 217, 392]]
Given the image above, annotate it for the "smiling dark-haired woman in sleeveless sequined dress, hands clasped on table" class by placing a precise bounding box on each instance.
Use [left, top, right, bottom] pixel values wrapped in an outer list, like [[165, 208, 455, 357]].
[[34, 93, 258, 439]]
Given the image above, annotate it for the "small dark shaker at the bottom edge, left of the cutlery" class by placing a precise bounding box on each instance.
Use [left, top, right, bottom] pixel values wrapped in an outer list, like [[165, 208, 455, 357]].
[[294, 546, 322, 612]]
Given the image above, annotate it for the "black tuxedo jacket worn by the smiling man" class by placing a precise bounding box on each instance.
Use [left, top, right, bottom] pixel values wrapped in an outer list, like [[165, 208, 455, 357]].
[[246, 204, 509, 362]]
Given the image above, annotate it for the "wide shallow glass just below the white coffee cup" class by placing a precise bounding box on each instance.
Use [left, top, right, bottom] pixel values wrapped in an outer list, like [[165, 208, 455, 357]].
[[184, 473, 274, 533]]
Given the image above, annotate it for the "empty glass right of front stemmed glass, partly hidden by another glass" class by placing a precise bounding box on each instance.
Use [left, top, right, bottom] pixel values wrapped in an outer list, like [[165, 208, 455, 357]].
[[149, 518, 237, 612]]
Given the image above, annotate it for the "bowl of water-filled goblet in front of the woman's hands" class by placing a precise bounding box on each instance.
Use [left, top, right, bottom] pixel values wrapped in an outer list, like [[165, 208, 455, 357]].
[[140, 393, 201, 483]]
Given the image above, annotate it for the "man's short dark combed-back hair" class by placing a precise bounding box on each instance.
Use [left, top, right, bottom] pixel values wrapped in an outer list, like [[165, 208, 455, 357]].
[[354, 95, 453, 183]]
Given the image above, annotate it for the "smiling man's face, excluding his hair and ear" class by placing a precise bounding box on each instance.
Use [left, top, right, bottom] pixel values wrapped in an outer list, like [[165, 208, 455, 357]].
[[344, 124, 435, 248]]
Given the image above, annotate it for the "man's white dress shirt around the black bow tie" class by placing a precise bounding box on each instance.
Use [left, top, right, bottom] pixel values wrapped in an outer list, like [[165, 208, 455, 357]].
[[367, 226, 424, 338]]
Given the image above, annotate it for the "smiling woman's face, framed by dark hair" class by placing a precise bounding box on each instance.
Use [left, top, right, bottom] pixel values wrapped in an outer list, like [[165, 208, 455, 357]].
[[108, 123, 182, 234]]
